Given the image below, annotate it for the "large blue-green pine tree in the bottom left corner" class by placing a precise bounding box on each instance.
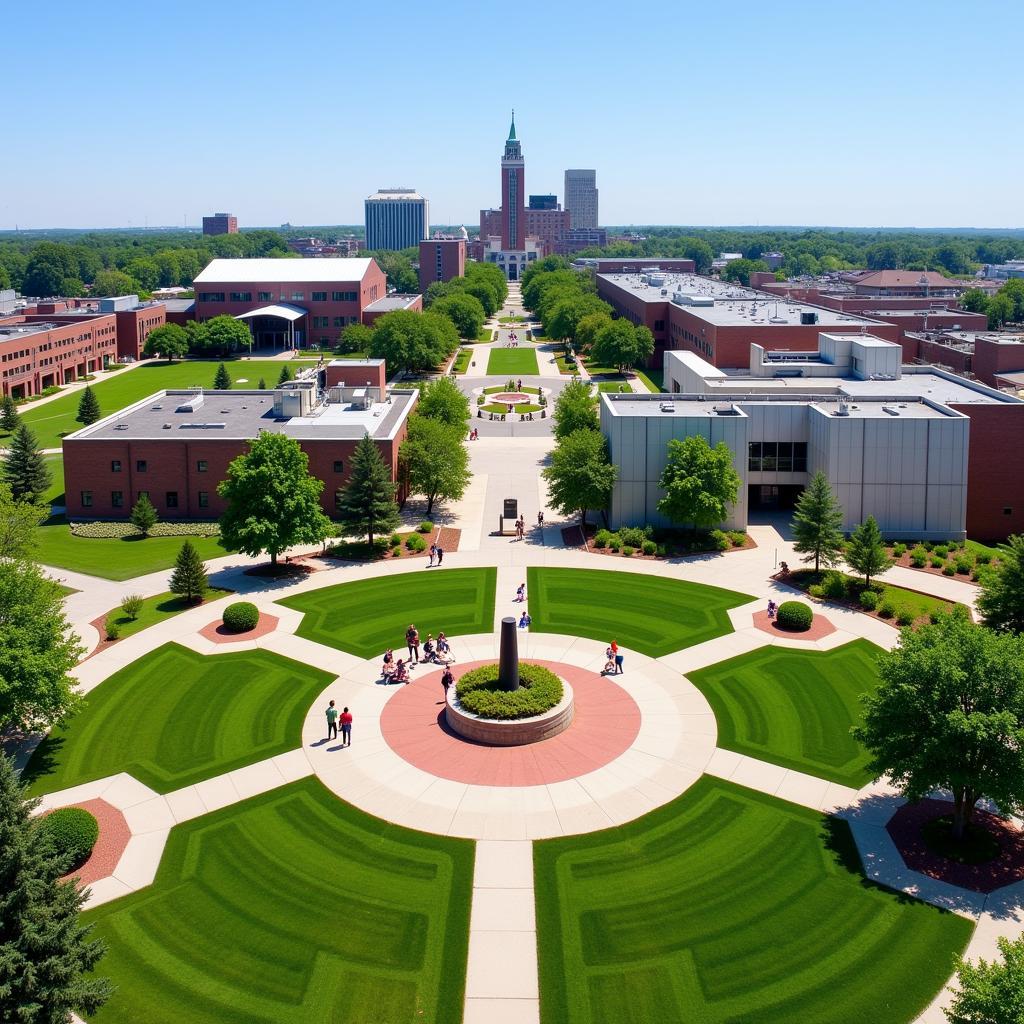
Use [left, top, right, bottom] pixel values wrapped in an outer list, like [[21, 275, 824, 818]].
[[0, 755, 113, 1024]]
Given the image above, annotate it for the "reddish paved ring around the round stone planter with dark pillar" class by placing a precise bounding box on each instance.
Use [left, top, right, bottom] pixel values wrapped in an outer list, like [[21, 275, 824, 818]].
[[381, 662, 640, 786]]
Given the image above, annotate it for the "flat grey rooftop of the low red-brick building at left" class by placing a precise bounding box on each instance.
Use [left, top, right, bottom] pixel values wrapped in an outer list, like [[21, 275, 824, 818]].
[[65, 389, 419, 442]]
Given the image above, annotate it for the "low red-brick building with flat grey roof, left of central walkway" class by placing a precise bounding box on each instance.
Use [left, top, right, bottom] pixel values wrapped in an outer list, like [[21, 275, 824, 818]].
[[63, 359, 419, 519]]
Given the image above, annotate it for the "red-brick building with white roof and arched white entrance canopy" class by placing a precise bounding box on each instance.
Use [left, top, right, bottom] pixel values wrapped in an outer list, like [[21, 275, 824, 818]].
[[194, 257, 387, 348]]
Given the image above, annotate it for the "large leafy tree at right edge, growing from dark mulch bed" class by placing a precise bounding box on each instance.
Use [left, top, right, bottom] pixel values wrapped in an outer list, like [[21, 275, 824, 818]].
[[853, 607, 1024, 840]]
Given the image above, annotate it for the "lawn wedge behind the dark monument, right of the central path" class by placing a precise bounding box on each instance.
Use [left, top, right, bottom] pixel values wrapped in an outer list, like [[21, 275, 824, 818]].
[[526, 566, 754, 655]]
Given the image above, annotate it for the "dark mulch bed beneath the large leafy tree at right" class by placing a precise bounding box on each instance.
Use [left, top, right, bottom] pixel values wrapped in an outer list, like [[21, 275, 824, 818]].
[[886, 800, 1024, 893]]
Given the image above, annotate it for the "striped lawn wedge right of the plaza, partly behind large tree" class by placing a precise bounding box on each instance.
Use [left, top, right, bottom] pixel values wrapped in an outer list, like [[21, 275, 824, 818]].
[[688, 640, 880, 790]]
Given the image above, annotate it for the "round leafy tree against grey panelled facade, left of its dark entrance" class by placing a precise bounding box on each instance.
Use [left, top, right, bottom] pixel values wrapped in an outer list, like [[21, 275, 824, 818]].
[[657, 435, 740, 528]]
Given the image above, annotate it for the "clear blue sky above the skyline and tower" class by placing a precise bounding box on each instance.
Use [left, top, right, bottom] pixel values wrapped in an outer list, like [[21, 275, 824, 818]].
[[8, 0, 1024, 228]]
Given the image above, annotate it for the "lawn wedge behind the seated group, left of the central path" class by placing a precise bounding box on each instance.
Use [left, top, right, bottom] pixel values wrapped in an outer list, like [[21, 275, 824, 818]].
[[278, 567, 498, 657]]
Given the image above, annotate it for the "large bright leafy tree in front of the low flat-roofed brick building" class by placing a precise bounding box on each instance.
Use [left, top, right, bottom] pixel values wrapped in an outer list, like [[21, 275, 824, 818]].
[[217, 430, 331, 565]]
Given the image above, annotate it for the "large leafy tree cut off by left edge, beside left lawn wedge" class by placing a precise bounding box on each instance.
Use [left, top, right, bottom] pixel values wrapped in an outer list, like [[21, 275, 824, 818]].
[[0, 559, 84, 733]]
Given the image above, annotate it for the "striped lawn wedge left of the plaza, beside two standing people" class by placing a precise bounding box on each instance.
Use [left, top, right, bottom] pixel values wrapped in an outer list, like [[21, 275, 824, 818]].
[[26, 644, 332, 794]]
